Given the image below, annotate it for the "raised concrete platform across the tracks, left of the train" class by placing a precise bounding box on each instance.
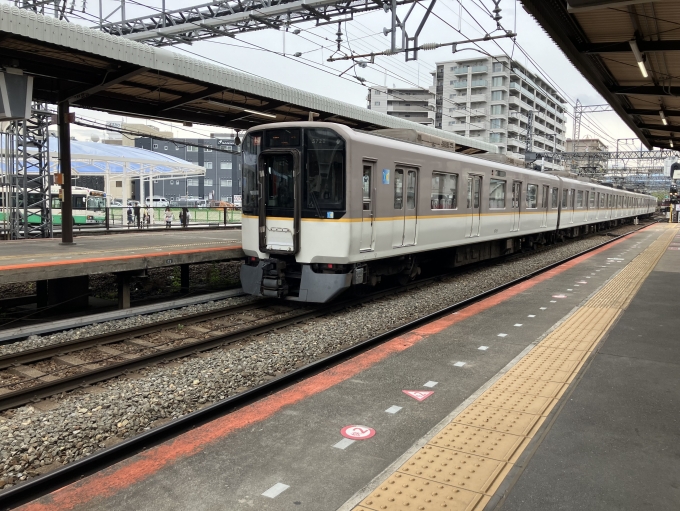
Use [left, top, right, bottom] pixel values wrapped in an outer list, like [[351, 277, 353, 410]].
[[0, 229, 244, 309]]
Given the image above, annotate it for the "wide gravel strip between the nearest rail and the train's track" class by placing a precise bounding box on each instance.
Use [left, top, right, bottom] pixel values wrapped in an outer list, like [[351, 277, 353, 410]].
[[0, 226, 652, 488]]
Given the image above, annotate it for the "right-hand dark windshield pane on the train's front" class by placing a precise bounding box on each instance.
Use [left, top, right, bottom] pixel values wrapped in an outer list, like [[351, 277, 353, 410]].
[[303, 128, 345, 212]]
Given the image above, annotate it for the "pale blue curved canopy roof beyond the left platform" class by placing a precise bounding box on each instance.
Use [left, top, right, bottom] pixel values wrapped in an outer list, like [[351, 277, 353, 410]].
[[50, 137, 205, 179]]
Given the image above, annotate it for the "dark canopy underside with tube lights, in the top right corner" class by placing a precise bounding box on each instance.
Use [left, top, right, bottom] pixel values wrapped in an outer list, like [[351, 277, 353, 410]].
[[522, 0, 680, 149]]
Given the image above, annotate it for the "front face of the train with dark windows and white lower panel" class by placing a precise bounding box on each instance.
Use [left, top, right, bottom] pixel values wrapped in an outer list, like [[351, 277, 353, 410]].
[[241, 122, 353, 302]]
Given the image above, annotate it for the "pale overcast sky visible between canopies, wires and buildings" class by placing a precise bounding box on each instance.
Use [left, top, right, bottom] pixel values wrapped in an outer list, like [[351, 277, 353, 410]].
[[38, 0, 639, 153]]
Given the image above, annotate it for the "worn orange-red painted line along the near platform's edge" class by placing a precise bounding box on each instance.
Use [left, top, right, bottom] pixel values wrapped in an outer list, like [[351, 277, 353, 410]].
[[19, 235, 622, 511]]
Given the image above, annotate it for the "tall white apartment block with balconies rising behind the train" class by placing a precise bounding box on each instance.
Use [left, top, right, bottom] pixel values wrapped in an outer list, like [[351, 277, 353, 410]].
[[430, 55, 566, 170]]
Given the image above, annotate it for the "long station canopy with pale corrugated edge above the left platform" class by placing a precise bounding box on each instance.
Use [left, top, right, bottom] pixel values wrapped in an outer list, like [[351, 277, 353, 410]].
[[0, 4, 499, 154]]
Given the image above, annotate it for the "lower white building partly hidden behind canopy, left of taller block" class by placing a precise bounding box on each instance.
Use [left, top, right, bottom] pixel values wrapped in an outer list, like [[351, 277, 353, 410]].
[[366, 87, 434, 126]]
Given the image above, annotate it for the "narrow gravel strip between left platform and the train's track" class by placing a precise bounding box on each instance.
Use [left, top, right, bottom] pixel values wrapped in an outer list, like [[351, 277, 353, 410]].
[[0, 296, 253, 355]]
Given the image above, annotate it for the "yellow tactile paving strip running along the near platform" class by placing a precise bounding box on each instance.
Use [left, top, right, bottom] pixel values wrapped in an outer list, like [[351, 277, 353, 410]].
[[353, 224, 678, 511]]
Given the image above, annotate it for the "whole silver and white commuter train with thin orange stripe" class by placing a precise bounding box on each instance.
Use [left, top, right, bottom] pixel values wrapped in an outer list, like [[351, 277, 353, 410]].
[[241, 122, 656, 302]]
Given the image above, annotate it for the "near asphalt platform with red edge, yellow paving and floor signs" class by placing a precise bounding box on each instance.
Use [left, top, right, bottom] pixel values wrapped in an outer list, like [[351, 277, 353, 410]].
[[13, 224, 680, 511]]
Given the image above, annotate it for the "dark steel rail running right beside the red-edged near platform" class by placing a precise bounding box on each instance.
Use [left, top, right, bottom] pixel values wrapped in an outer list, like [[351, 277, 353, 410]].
[[0, 222, 656, 509]]
